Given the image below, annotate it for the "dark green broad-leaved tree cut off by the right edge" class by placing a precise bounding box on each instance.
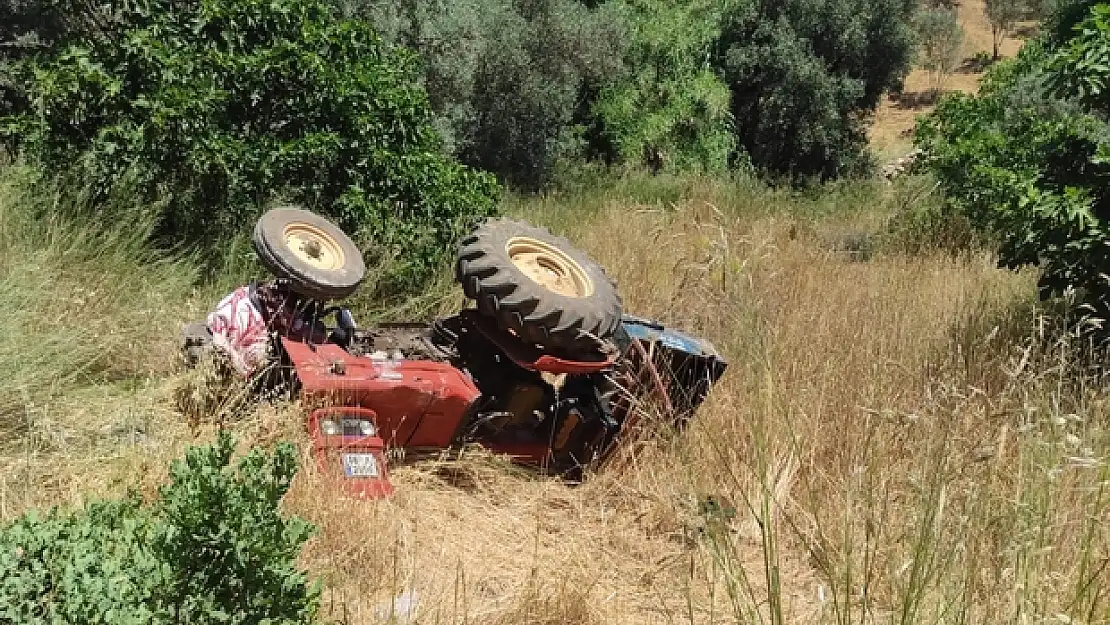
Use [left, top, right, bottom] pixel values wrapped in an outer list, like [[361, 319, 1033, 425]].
[[917, 6, 1110, 314]]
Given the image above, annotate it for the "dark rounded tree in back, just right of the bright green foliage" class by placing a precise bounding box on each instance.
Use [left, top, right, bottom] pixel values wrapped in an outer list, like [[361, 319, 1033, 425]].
[[715, 0, 917, 179]]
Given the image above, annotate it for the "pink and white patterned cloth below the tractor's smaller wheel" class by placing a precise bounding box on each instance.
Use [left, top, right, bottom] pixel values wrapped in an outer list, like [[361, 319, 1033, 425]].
[[208, 286, 270, 376]]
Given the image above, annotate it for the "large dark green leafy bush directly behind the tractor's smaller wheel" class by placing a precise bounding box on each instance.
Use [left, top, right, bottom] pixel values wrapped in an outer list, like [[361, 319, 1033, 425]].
[[2, 0, 497, 286]]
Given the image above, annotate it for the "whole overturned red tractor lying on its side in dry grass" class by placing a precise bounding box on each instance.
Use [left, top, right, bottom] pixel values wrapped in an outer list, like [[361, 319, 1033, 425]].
[[186, 209, 727, 497]]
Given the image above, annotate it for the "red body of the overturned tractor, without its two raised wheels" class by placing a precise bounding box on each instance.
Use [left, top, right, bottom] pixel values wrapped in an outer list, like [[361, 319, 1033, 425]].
[[279, 311, 725, 498]]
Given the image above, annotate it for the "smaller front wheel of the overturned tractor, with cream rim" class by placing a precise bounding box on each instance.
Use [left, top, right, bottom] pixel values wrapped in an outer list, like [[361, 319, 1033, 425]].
[[251, 206, 366, 301]]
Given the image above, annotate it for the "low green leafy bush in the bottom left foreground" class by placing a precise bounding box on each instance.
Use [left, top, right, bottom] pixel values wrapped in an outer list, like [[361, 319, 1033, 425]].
[[0, 435, 319, 625]]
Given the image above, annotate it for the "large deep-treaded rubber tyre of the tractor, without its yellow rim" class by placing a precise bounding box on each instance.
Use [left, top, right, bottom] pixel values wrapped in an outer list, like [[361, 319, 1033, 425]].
[[455, 220, 622, 352]]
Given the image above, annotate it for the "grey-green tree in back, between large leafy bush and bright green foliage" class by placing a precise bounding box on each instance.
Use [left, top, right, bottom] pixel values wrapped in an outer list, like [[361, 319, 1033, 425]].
[[359, 0, 625, 189]]
